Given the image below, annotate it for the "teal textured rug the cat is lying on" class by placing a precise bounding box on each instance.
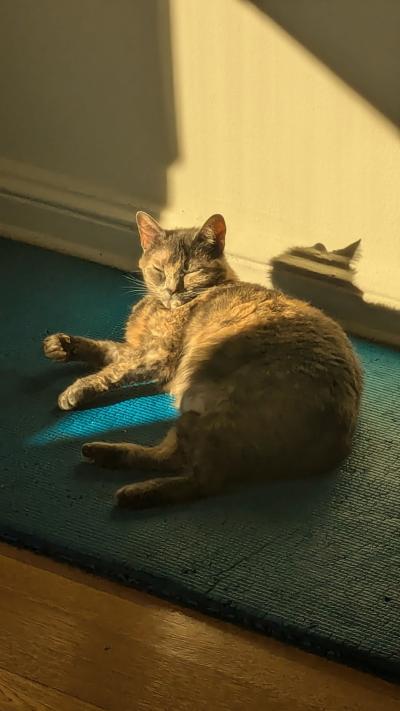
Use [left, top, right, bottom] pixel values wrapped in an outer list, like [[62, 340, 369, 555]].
[[0, 240, 400, 678]]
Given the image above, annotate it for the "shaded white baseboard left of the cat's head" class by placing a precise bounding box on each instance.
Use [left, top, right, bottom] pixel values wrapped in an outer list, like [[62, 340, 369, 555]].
[[0, 158, 150, 270]]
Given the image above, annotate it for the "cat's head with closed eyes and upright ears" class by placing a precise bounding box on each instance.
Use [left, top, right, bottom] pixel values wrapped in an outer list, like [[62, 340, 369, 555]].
[[136, 212, 235, 309]]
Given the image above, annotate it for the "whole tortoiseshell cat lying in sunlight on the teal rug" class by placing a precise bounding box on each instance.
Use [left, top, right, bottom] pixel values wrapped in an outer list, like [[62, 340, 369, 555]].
[[44, 212, 363, 509]]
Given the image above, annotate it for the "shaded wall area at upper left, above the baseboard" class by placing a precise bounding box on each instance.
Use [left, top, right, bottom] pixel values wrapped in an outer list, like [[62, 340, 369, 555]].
[[0, 0, 176, 205]]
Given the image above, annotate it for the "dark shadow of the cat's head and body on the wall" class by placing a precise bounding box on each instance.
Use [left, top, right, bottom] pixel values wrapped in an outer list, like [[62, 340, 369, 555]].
[[270, 240, 400, 348]]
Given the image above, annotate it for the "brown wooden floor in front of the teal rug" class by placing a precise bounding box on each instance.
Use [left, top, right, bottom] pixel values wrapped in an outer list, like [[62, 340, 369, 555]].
[[0, 544, 400, 711]]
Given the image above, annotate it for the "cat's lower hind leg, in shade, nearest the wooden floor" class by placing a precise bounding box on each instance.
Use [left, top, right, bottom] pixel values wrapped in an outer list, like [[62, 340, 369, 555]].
[[116, 475, 211, 509]]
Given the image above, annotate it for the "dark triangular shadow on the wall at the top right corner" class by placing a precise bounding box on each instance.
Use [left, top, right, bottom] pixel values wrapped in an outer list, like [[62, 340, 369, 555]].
[[242, 0, 400, 126]]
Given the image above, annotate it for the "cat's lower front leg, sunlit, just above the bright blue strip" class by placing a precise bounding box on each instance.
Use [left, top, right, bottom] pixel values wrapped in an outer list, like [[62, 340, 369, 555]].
[[58, 358, 157, 410]]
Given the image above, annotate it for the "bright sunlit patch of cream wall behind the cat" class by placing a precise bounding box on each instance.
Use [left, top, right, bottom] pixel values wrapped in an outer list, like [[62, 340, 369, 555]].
[[162, 0, 400, 301]]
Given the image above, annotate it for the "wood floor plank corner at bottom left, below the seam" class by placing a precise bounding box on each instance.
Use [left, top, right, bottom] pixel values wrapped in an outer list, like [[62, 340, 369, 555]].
[[0, 669, 102, 711]]
